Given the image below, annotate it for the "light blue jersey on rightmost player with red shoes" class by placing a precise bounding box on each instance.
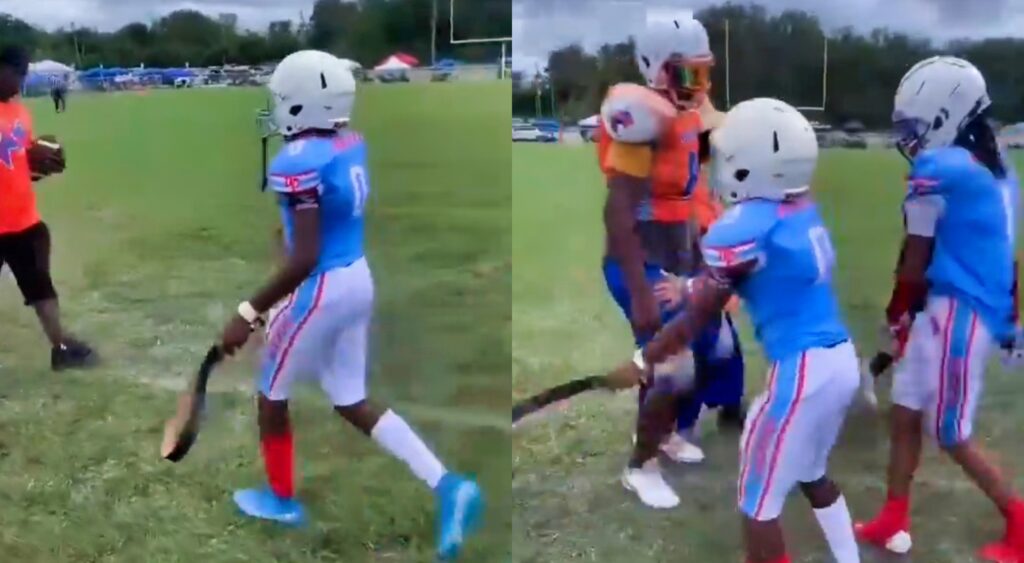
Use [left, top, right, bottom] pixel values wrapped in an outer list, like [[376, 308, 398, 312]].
[[904, 146, 1018, 341]]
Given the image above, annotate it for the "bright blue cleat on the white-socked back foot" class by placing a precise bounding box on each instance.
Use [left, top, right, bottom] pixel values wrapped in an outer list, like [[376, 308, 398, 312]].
[[434, 473, 483, 561]]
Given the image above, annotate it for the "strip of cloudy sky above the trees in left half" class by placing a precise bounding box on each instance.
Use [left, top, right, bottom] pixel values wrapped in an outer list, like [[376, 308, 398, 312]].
[[0, 0, 313, 31]]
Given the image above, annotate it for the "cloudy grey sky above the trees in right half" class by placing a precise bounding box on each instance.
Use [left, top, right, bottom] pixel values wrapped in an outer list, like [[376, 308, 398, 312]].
[[516, 0, 1024, 69]]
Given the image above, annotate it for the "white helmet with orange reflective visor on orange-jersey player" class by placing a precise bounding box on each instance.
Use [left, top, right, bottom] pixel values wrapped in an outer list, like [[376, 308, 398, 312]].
[[636, 17, 715, 107]]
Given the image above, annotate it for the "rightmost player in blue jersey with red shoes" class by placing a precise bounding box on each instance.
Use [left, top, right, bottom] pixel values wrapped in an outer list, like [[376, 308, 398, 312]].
[[857, 56, 1024, 562]]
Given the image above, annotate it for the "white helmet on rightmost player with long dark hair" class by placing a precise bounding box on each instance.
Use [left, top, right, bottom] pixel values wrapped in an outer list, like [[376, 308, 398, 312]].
[[893, 56, 992, 157]]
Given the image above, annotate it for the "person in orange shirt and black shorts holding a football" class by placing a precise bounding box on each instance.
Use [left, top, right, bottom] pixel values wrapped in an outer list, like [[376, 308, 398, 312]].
[[0, 46, 95, 371]]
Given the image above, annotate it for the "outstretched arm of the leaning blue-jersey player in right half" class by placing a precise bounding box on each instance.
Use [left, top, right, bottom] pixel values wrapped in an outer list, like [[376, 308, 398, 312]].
[[643, 259, 757, 365]]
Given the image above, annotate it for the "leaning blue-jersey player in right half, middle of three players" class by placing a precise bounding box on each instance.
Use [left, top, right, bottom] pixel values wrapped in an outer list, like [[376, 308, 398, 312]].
[[623, 98, 860, 563]]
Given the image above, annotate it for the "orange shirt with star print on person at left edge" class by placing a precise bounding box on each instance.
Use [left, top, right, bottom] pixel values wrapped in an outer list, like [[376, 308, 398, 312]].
[[0, 99, 40, 234]]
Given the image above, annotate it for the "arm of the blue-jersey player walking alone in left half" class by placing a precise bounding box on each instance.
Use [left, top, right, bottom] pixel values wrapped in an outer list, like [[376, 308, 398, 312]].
[[243, 187, 321, 313]]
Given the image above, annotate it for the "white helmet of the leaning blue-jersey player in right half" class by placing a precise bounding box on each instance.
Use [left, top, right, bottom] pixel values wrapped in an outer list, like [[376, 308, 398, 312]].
[[711, 98, 818, 203]]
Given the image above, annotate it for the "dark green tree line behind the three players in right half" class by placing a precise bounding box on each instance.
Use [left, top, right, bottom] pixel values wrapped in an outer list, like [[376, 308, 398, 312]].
[[513, 4, 1024, 128]]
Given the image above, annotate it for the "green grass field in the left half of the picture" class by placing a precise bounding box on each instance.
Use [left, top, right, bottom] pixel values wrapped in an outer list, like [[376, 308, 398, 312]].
[[0, 83, 511, 563]]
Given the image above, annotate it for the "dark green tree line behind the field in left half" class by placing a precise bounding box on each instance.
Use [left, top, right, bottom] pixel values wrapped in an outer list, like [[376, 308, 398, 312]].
[[0, 0, 512, 69]]
